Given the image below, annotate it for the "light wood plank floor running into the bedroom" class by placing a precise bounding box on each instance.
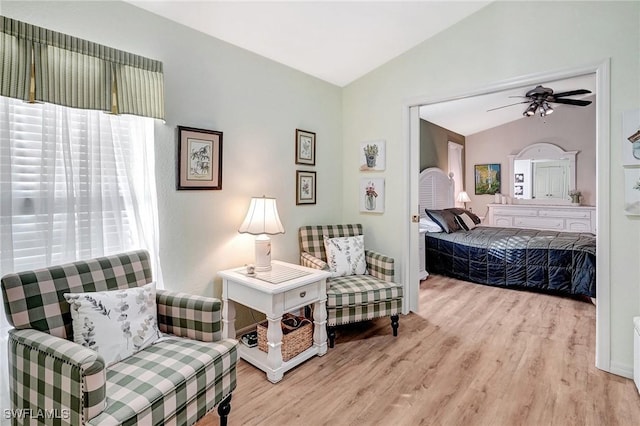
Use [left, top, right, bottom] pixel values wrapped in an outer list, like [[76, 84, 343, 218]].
[[198, 276, 640, 426]]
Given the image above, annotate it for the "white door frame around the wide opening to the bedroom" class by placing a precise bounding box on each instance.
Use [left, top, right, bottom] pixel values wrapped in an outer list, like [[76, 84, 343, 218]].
[[403, 58, 612, 375]]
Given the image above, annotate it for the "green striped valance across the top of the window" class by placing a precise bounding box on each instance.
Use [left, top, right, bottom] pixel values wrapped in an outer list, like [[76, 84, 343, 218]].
[[0, 16, 164, 119]]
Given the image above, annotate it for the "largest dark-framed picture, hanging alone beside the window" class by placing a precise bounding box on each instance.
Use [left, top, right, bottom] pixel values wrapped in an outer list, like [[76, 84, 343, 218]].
[[176, 126, 222, 190]]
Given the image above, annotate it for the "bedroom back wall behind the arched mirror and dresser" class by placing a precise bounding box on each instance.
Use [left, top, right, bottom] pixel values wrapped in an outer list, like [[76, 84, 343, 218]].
[[465, 98, 596, 215]]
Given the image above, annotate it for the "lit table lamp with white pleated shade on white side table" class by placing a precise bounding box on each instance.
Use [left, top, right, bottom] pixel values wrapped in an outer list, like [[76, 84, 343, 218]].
[[238, 195, 284, 272]]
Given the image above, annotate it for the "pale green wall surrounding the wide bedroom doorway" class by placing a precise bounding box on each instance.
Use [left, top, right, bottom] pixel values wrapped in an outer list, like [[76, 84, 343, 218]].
[[343, 1, 640, 371]]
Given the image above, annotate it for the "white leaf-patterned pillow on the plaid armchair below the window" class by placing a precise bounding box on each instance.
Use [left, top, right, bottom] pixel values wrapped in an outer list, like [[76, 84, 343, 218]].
[[64, 282, 160, 366]]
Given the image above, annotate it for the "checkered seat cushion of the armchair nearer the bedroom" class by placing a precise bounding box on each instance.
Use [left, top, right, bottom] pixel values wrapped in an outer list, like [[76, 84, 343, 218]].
[[327, 275, 402, 309]]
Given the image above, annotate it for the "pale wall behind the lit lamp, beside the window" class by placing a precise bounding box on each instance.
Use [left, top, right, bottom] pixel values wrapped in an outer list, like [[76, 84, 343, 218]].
[[1, 1, 342, 326]]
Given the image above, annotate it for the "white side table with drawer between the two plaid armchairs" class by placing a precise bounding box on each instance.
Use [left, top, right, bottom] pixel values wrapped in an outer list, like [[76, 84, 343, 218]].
[[218, 260, 331, 383]]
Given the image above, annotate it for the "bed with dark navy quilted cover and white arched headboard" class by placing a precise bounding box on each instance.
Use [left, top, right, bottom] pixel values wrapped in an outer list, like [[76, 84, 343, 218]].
[[420, 168, 596, 298]]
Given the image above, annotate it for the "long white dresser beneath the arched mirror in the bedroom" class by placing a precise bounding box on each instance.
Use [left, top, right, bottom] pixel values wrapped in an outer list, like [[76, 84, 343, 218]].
[[487, 204, 596, 234]]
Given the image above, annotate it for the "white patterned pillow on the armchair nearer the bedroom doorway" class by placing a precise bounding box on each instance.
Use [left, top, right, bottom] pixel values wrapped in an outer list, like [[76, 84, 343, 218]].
[[323, 235, 367, 277]]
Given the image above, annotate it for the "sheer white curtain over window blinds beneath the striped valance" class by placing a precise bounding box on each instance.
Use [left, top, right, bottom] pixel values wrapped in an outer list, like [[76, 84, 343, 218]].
[[0, 97, 162, 337]]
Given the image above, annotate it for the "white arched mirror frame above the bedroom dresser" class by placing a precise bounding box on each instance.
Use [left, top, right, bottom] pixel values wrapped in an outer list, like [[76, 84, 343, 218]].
[[509, 142, 580, 205]]
